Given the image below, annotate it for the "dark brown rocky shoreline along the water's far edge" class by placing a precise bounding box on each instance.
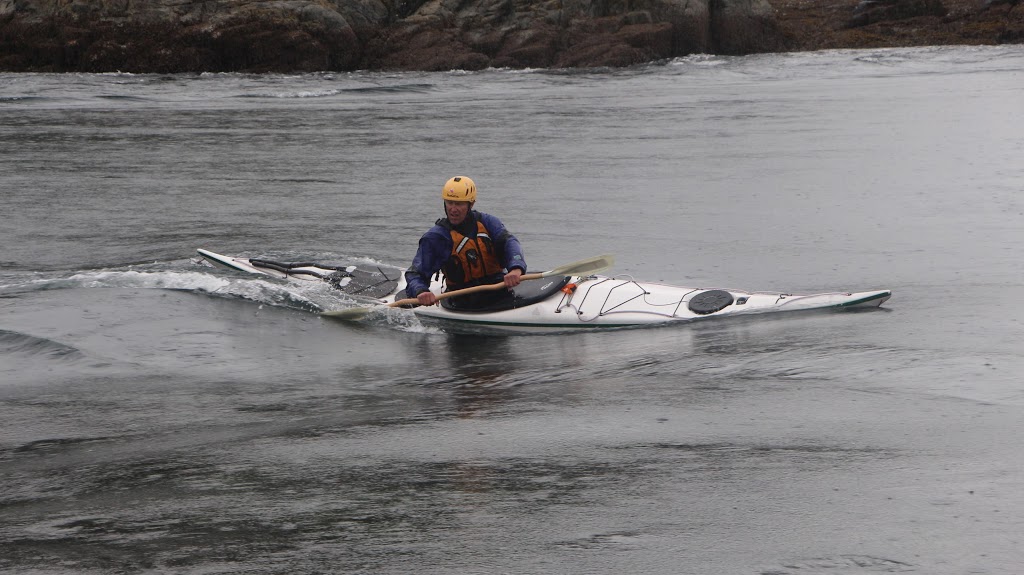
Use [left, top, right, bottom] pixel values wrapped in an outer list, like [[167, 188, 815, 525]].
[[0, 0, 1024, 73]]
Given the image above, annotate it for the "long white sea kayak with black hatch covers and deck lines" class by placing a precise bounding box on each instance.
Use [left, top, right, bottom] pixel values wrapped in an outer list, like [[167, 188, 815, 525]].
[[199, 250, 892, 333]]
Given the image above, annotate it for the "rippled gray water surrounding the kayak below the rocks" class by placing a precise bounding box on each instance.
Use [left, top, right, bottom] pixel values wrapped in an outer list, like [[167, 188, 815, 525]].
[[6, 46, 1024, 575]]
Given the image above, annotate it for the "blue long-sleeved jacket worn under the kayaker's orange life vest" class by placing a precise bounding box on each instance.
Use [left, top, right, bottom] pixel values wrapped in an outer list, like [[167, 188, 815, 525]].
[[406, 211, 526, 298]]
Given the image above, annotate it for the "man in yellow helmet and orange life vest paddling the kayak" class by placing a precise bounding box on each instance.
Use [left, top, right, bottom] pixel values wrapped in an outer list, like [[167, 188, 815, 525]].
[[406, 176, 526, 309]]
